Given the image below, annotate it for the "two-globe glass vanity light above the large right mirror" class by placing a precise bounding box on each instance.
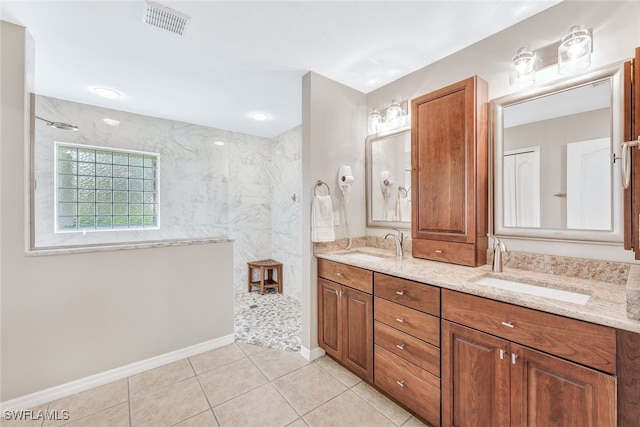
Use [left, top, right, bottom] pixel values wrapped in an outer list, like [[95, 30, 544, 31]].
[[509, 26, 593, 89]]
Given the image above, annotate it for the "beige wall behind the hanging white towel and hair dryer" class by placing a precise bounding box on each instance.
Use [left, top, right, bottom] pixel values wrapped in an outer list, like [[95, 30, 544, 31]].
[[302, 72, 366, 351]]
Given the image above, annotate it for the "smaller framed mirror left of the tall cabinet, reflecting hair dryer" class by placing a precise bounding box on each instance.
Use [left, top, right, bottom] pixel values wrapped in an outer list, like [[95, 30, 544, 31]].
[[366, 128, 411, 228]]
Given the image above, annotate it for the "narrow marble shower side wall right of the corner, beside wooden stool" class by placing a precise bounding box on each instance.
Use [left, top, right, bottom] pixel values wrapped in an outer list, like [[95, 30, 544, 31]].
[[271, 126, 302, 301]]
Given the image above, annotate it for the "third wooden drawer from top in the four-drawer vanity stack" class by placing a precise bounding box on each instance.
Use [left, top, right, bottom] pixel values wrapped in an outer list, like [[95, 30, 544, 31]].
[[374, 321, 440, 377]]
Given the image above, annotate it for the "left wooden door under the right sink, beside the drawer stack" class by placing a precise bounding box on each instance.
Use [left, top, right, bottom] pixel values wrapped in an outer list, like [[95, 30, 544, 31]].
[[442, 321, 510, 427]]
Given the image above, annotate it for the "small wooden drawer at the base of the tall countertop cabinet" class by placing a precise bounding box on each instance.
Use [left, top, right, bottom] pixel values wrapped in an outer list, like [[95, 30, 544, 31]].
[[411, 238, 480, 267]]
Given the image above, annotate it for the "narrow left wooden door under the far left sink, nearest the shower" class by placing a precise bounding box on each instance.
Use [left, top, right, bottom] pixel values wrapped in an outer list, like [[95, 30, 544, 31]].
[[318, 278, 343, 360]]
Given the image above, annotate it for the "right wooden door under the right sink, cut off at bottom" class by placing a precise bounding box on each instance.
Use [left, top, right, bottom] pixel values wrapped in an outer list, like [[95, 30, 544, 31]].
[[508, 343, 616, 427]]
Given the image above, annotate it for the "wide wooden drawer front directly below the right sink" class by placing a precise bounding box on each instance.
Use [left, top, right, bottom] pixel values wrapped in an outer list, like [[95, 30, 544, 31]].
[[442, 289, 616, 373]]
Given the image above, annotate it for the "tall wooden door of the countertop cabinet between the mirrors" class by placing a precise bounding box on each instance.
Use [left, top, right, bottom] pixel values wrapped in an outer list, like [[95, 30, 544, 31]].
[[411, 77, 486, 243]]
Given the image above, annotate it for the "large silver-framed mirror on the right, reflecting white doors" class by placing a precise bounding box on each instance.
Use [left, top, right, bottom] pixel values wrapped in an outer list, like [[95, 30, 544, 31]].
[[490, 65, 624, 242]]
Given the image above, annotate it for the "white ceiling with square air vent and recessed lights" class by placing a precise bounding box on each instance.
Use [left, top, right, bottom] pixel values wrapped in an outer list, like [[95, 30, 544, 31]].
[[0, 0, 559, 137]]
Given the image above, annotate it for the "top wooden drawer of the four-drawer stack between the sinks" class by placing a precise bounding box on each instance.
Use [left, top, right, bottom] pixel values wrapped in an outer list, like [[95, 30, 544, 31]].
[[373, 273, 440, 316]]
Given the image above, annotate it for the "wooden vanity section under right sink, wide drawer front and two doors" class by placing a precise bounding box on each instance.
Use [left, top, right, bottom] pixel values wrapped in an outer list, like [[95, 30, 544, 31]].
[[442, 290, 617, 427]]
